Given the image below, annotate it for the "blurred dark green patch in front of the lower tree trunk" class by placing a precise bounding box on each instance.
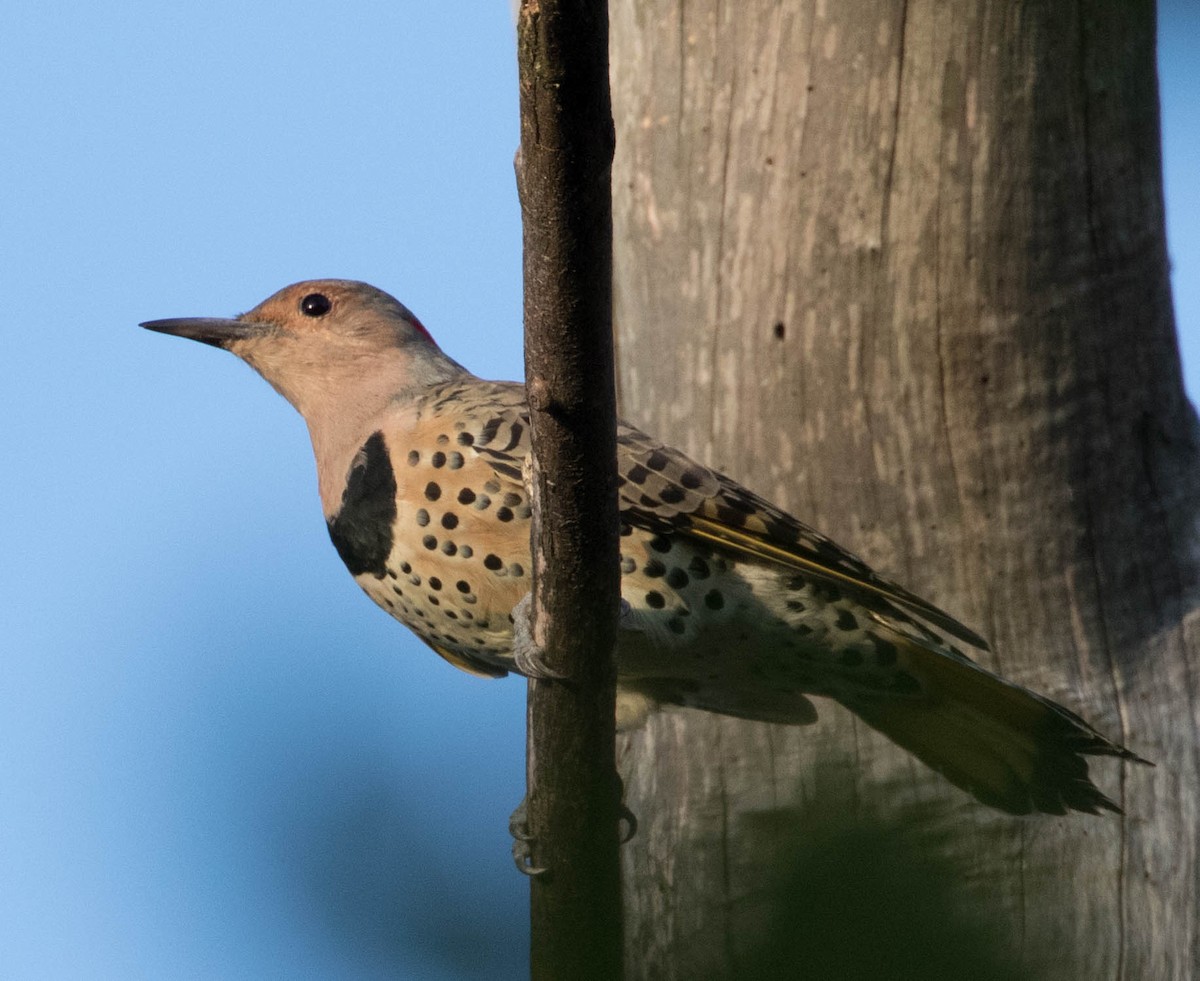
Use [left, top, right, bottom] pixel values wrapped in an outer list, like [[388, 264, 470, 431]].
[[737, 768, 1036, 981]]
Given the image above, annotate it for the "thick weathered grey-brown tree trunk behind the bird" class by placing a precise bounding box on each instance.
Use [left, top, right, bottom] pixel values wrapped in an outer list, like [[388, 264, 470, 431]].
[[612, 0, 1200, 979]]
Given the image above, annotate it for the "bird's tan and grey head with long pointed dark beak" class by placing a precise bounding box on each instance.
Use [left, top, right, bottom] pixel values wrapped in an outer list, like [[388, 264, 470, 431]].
[[142, 279, 463, 421]]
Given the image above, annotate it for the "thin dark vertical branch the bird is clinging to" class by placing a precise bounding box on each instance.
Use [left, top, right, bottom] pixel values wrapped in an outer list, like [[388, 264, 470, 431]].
[[517, 0, 622, 981]]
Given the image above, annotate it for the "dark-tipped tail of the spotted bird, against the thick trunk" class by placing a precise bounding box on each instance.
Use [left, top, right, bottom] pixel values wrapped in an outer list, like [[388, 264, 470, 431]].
[[844, 638, 1146, 814]]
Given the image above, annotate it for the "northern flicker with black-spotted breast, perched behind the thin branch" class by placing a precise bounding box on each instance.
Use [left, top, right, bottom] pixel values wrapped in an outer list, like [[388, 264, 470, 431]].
[[142, 279, 1139, 814]]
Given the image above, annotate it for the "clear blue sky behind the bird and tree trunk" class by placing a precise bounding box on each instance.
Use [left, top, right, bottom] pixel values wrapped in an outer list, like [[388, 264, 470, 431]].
[[0, 0, 1200, 979]]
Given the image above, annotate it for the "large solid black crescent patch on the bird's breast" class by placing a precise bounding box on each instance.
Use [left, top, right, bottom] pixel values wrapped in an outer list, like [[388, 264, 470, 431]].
[[326, 433, 396, 579]]
